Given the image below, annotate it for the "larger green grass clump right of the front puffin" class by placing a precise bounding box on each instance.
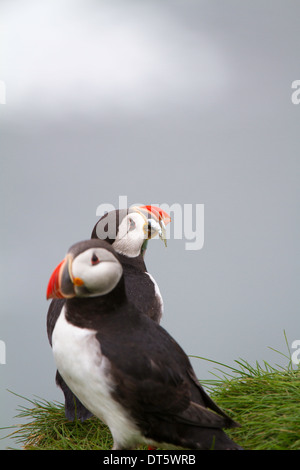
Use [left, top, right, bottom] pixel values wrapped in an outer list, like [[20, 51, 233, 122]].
[[195, 360, 300, 450]]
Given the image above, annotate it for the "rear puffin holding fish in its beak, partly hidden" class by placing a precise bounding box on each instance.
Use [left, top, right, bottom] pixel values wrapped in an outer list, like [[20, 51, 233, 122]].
[[47, 205, 171, 422]]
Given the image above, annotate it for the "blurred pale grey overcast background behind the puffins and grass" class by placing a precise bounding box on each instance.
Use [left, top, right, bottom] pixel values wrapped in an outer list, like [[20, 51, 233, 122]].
[[0, 0, 300, 448]]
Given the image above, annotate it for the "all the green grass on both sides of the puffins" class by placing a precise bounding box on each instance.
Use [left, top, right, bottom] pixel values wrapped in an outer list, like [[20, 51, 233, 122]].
[[3, 336, 300, 450]]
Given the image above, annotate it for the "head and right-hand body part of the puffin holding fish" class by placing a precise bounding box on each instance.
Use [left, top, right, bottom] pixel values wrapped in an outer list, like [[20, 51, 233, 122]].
[[91, 206, 171, 322]]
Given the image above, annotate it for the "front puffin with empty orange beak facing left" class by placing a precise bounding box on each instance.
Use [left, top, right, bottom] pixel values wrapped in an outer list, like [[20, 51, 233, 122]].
[[47, 239, 242, 450]]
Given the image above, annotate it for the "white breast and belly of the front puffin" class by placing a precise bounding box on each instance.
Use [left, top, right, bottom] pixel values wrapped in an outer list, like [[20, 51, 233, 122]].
[[52, 307, 141, 445]]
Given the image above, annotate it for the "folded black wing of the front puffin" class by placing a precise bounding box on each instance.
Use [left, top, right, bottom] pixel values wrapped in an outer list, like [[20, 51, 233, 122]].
[[97, 312, 236, 428]]
